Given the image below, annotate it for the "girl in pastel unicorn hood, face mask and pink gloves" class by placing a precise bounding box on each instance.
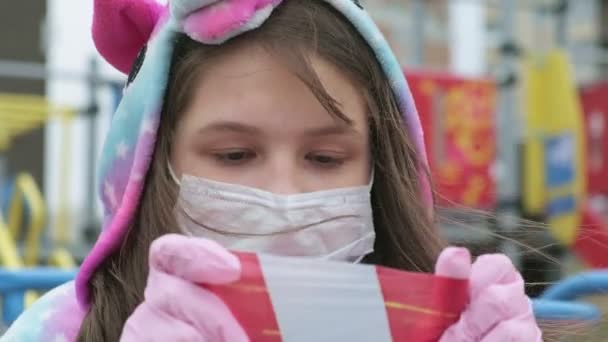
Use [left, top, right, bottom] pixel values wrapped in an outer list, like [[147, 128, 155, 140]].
[[5, 0, 541, 342]]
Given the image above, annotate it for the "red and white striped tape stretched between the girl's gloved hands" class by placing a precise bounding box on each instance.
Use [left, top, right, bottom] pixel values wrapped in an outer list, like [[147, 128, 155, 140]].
[[207, 253, 468, 342]]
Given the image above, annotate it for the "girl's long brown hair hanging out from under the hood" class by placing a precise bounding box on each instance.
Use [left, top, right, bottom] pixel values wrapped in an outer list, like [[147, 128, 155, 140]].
[[78, 0, 443, 341]]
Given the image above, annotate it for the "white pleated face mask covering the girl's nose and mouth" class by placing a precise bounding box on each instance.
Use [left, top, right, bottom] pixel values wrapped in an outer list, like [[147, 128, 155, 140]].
[[169, 168, 376, 262]]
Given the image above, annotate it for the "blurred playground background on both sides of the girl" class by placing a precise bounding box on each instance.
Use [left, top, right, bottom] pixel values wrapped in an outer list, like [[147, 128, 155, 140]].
[[0, 0, 608, 337]]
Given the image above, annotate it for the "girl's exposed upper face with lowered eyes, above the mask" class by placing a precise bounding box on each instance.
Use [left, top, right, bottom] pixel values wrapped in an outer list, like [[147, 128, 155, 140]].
[[171, 46, 371, 194]]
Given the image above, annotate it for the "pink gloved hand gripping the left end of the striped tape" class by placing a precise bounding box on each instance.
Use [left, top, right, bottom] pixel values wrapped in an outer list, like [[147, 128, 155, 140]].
[[120, 235, 249, 342]]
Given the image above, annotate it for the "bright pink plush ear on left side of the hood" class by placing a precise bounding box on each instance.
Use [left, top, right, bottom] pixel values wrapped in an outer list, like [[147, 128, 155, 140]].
[[93, 0, 166, 74]]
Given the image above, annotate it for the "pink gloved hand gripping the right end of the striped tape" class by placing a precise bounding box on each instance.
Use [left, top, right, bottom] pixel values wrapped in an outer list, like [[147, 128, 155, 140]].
[[435, 248, 542, 342]]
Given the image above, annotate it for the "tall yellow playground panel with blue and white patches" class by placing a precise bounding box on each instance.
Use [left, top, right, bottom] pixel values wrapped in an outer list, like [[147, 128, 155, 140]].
[[522, 50, 586, 246]]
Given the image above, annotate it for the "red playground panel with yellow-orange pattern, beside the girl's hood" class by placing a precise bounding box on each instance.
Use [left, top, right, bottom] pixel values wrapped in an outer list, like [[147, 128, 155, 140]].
[[406, 71, 496, 210]]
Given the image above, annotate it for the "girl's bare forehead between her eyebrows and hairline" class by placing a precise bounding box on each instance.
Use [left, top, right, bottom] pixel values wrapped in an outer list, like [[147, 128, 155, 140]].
[[179, 48, 367, 135]]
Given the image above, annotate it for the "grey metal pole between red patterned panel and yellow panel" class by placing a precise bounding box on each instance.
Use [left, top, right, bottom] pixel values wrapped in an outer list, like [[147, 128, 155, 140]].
[[496, 0, 521, 267]]
